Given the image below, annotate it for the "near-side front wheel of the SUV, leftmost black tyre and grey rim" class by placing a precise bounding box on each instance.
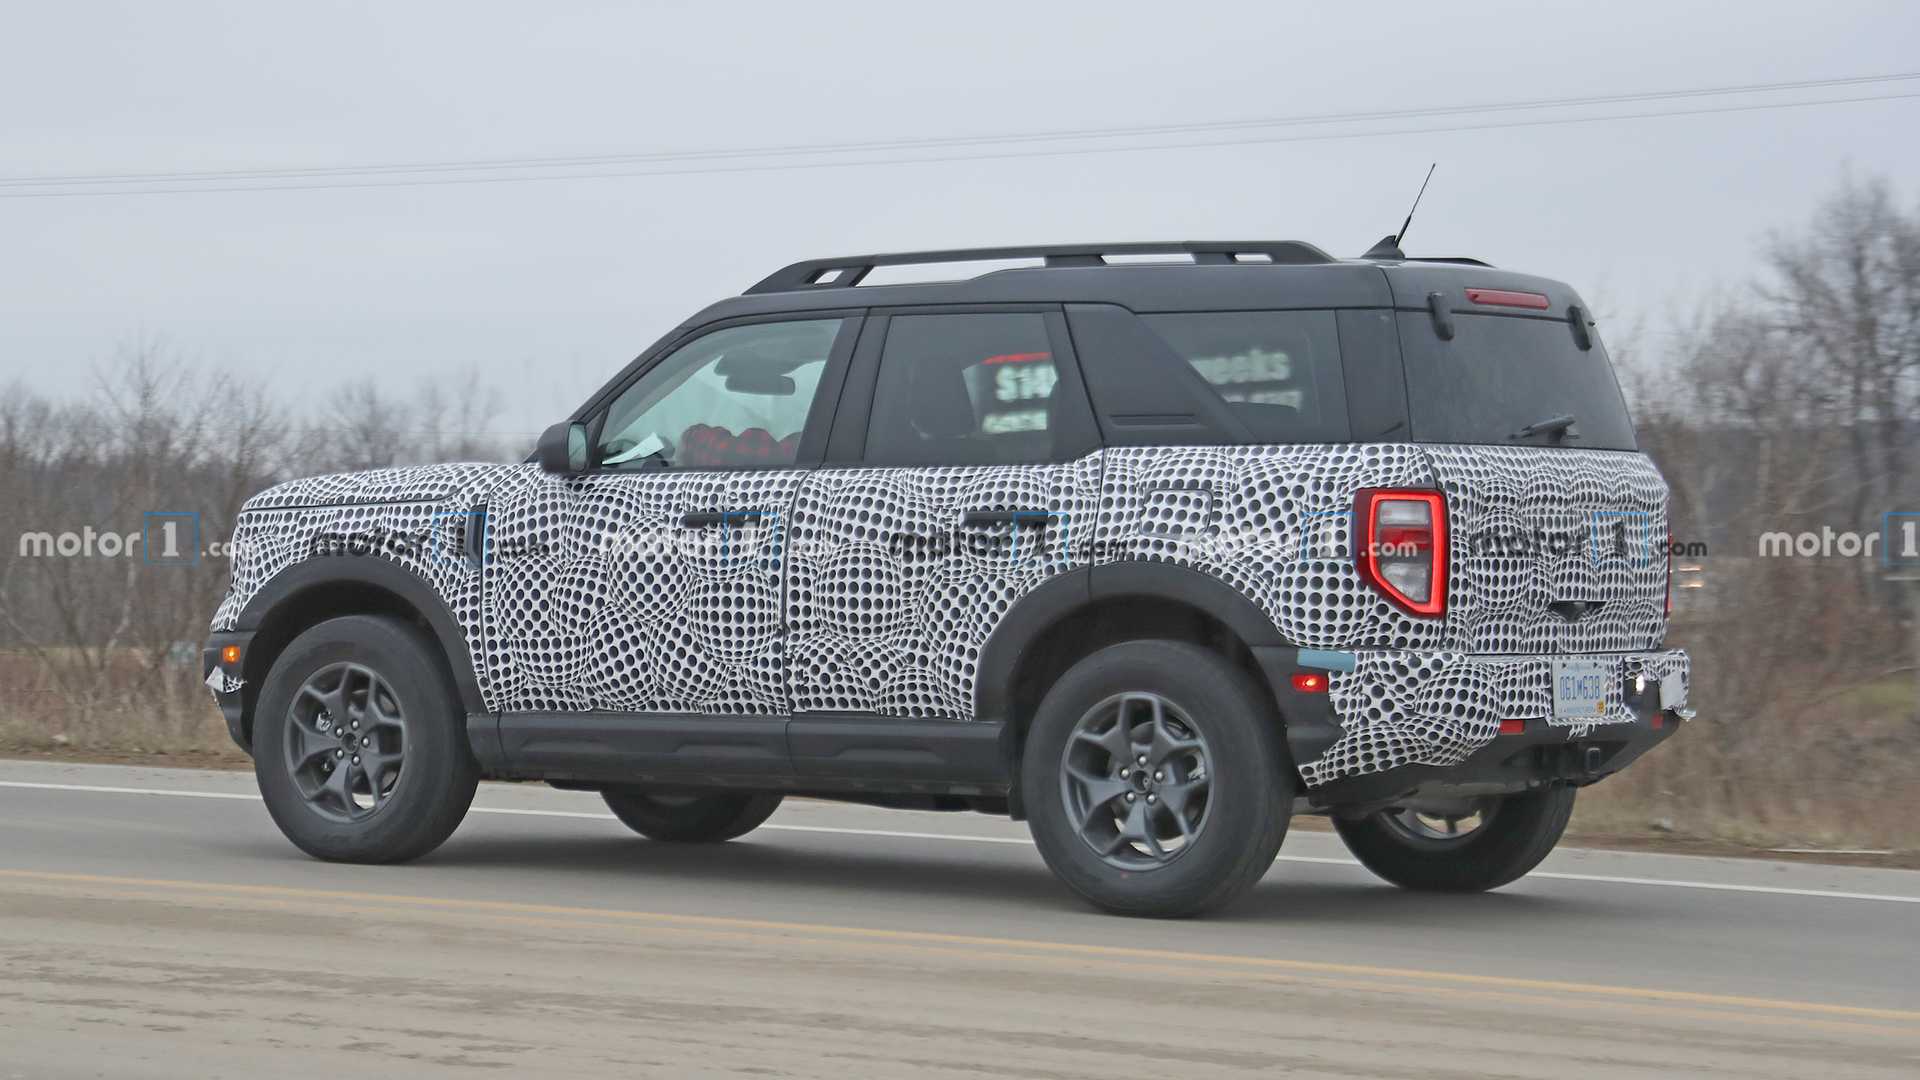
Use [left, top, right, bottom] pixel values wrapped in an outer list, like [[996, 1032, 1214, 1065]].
[[253, 615, 480, 863]]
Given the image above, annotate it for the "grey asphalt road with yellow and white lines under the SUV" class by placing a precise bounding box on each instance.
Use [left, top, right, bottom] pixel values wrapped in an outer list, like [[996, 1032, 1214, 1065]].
[[0, 761, 1920, 1080]]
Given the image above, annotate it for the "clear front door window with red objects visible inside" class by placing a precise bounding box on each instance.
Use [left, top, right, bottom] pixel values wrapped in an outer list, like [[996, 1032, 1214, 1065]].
[[595, 319, 847, 469]]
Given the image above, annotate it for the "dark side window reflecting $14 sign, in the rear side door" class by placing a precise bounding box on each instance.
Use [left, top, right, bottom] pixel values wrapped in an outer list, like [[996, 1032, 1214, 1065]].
[[866, 311, 1060, 465]]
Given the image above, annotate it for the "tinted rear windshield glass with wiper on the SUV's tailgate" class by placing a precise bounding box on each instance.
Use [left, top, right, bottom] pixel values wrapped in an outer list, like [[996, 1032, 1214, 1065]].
[[1400, 311, 1634, 450]]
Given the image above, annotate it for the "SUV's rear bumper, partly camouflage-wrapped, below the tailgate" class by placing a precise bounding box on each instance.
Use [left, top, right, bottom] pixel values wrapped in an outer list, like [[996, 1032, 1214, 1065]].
[[1288, 650, 1692, 805]]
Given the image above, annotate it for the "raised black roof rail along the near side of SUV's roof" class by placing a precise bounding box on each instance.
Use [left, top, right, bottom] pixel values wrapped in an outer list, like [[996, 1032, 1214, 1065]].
[[747, 240, 1334, 296]]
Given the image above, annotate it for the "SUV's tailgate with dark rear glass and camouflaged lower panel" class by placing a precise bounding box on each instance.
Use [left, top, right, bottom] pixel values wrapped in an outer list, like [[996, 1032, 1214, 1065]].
[[1388, 267, 1667, 653]]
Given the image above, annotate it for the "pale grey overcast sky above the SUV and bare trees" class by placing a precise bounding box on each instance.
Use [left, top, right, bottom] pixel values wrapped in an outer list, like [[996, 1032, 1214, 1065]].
[[0, 0, 1920, 440]]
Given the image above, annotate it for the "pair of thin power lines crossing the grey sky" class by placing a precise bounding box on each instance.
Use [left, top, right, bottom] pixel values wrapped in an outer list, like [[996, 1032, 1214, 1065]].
[[0, 83, 1920, 200]]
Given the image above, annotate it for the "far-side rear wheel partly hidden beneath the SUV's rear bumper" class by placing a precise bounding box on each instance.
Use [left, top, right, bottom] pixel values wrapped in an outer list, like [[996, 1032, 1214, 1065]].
[[1332, 784, 1574, 892]]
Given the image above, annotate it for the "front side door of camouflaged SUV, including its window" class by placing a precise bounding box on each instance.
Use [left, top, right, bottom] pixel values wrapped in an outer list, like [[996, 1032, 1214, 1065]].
[[480, 317, 860, 717]]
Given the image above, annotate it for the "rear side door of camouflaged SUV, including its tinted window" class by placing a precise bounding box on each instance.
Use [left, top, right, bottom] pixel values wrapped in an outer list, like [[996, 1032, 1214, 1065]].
[[787, 306, 1100, 718]]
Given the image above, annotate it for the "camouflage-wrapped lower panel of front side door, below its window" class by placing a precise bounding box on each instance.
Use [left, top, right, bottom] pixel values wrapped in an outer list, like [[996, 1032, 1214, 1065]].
[[474, 467, 804, 715]]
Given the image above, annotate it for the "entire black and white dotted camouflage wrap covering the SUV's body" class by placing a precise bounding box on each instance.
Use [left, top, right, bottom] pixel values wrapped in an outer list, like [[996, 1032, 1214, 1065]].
[[213, 444, 1686, 786]]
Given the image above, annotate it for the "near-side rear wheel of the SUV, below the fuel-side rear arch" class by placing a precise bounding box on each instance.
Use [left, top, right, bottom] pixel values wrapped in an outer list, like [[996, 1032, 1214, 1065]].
[[1020, 640, 1294, 919]]
